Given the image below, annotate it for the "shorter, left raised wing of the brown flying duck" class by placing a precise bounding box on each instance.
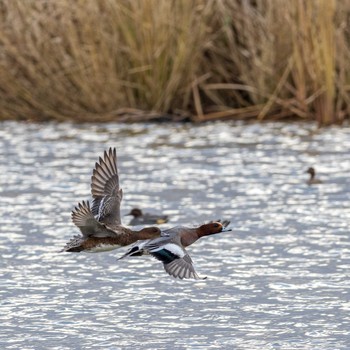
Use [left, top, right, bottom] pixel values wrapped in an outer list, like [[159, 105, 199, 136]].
[[72, 201, 118, 237]]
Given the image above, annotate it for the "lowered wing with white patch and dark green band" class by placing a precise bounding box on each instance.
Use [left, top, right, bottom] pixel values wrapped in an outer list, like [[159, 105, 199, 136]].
[[147, 242, 206, 279]]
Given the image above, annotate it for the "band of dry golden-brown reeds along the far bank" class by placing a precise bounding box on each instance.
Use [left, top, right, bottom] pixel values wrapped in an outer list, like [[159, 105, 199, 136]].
[[0, 0, 350, 125]]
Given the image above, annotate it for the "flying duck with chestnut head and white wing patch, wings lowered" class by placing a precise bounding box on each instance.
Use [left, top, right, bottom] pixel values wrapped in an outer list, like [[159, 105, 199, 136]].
[[118, 221, 231, 279]]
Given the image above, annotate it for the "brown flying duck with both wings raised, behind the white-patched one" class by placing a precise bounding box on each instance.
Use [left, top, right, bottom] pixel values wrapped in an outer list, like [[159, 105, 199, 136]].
[[62, 148, 161, 252]]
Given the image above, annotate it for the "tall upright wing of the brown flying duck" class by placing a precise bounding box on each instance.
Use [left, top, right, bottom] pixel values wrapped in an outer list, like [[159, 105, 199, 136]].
[[91, 148, 123, 225]]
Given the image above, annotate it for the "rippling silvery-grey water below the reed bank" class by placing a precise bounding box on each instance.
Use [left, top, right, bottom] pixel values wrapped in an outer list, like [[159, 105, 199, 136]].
[[0, 122, 350, 350]]
